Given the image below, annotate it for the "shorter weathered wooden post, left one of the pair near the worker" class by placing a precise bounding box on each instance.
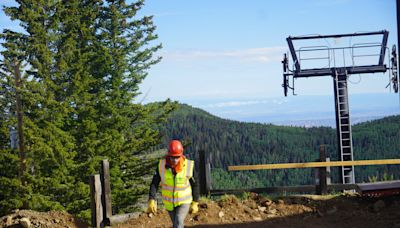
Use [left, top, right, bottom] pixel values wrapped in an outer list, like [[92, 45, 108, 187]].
[[89, 174, 103, 228]]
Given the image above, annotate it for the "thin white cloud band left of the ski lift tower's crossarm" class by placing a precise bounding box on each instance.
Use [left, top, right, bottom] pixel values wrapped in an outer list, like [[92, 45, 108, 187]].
[[161, 46, 287, 63]]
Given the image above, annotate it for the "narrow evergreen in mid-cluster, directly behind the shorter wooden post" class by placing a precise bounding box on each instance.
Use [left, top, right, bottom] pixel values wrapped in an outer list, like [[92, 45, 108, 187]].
[[50, 0, 102, 218]]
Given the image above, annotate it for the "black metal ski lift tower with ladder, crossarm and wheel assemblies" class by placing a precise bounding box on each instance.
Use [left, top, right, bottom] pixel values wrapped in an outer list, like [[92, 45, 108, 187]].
[[282, 30, 399, 184]]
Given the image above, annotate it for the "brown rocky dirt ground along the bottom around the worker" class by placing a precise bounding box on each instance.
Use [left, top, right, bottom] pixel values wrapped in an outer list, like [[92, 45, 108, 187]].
[[0, 194, 400, 228]]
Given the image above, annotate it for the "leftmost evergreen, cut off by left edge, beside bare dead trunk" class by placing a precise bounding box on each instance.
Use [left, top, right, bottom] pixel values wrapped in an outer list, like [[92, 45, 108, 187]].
[[0, 30, 27, 214]]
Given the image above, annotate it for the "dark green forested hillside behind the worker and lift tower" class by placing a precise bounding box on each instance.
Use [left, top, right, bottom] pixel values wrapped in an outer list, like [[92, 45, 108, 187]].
[[161, 104, 400, 188]]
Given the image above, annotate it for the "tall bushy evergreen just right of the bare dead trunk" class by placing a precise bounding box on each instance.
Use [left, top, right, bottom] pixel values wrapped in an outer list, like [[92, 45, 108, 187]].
[[1, 1, 74, 215]]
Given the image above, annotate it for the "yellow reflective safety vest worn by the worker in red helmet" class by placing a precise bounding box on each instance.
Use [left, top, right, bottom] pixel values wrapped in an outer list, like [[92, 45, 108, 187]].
[[158, 159, 194, 211]]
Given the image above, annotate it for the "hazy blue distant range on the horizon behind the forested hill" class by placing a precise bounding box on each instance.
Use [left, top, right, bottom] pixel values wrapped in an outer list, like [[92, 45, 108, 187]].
[[179, 93, 400, 128]]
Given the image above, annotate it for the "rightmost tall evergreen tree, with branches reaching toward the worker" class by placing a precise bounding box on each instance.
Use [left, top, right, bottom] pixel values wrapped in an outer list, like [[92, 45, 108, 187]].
[[89, 0, 175, 212]]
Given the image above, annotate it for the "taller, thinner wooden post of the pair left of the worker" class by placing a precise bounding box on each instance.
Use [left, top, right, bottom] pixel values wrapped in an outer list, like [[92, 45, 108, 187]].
[[100, 160, 112, 226]]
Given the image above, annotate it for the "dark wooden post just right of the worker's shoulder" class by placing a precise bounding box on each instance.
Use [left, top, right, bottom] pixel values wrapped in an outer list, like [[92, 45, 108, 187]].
[[199, 150, 211, 196]]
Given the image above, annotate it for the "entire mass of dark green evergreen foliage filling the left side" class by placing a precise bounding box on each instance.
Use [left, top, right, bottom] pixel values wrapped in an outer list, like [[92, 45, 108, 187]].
[[0, 0, 175, 221]]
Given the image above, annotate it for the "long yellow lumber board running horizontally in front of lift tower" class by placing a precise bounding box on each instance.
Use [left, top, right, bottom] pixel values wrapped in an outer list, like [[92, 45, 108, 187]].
[[228, 159, 400, 171]]
